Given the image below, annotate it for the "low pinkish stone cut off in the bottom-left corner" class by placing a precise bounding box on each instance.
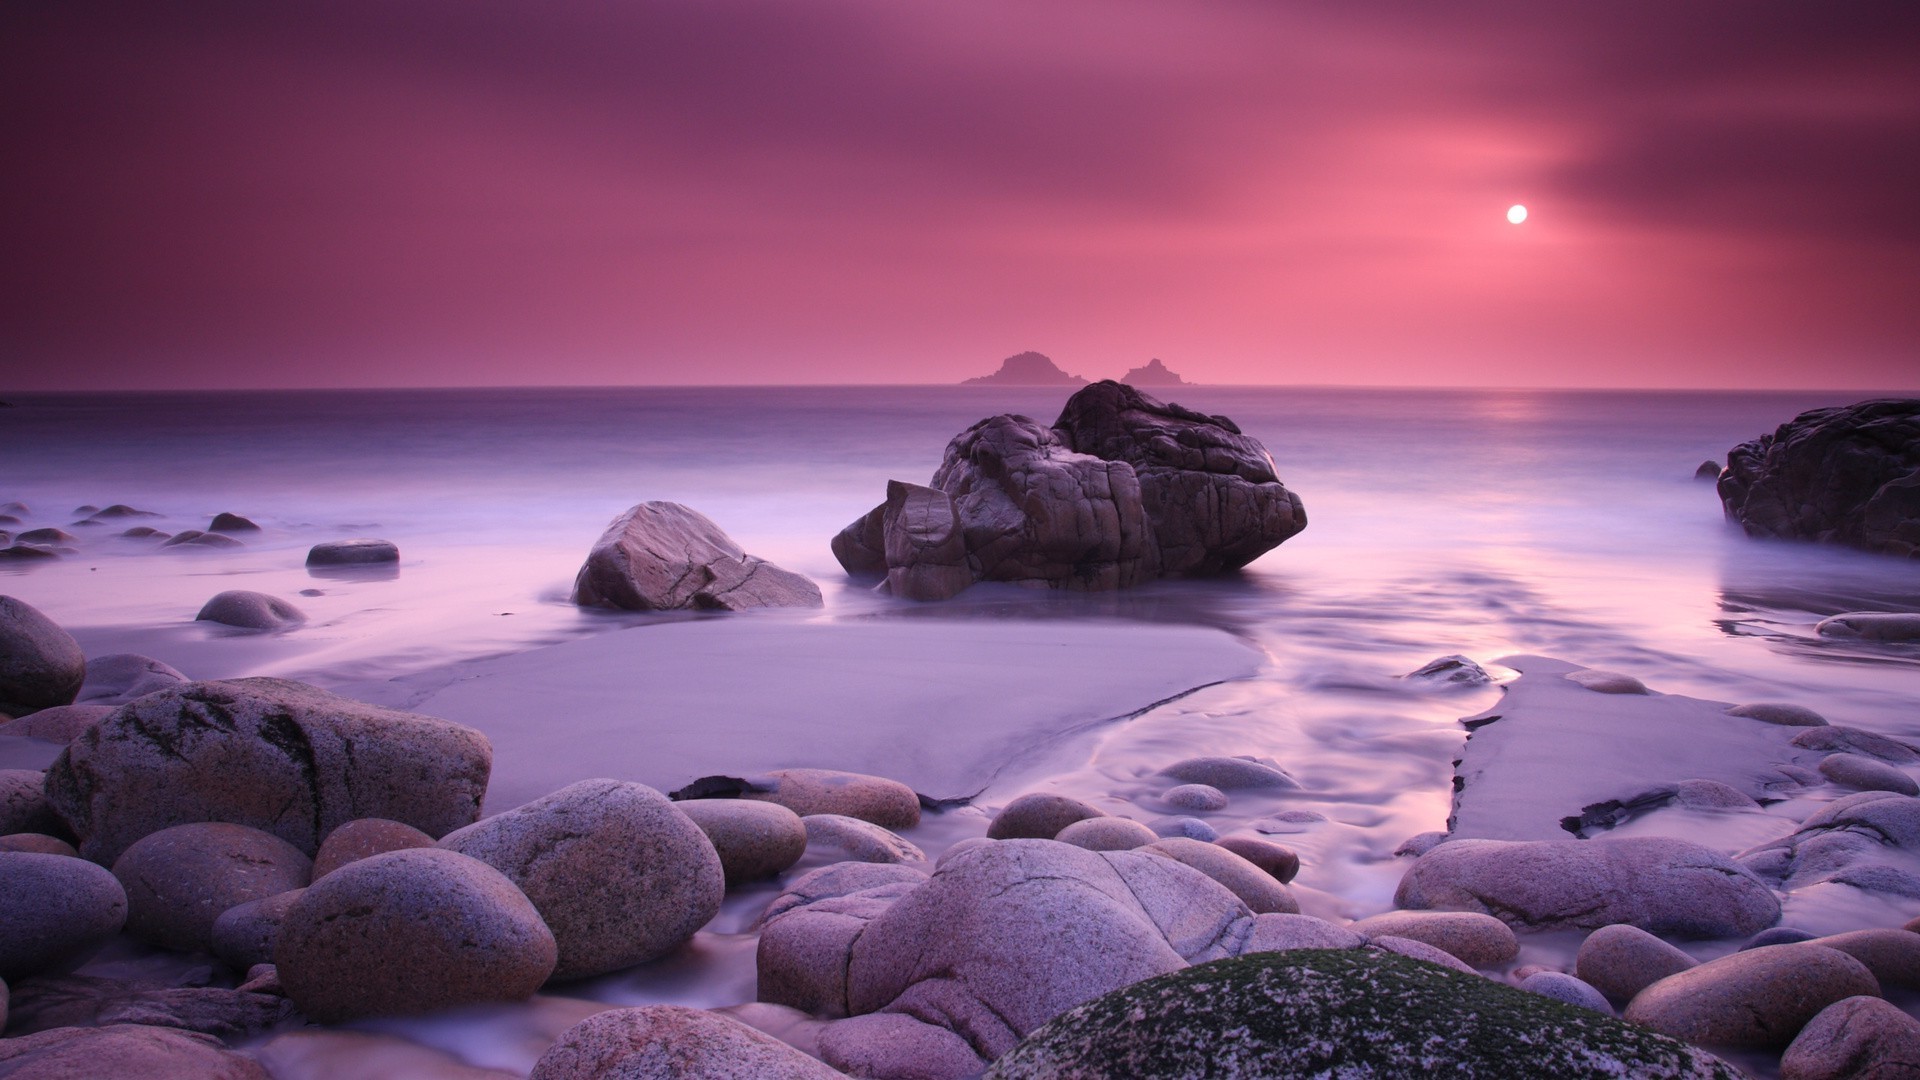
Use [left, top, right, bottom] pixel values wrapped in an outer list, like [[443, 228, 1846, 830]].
[[0, 1024, 271, 1080]]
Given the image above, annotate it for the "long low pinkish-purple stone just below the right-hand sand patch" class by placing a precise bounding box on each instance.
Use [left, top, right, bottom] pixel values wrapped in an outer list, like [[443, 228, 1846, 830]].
[[1394, 836, 1780, 938]]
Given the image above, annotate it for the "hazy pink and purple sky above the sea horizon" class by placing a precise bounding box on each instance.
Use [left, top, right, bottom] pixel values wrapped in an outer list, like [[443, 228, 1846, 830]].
[[0, 0, 1920, 390]]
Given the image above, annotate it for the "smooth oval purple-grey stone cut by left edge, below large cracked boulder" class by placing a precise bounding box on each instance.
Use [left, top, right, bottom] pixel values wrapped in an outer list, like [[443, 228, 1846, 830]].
[[0, 851, 127, 982]]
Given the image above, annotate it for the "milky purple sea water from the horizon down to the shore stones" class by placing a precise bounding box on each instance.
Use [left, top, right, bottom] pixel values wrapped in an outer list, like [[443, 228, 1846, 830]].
[[0, 388, 1920, 1063]]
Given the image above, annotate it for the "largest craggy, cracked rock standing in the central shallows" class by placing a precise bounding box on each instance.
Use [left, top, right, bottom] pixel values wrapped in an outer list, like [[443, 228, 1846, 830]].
[[833, 380, 1306, 600]]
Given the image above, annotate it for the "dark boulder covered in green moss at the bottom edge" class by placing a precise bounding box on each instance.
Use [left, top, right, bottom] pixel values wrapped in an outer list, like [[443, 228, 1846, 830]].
[[987, 949, 1741, 1080]]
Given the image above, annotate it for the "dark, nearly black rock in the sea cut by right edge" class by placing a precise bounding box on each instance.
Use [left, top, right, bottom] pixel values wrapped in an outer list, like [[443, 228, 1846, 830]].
[[1718, 398, 1920, 557]]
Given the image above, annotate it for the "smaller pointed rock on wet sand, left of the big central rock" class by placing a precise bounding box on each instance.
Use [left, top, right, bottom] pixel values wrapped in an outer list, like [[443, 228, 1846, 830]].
[[574, 502, 822, 611]]
